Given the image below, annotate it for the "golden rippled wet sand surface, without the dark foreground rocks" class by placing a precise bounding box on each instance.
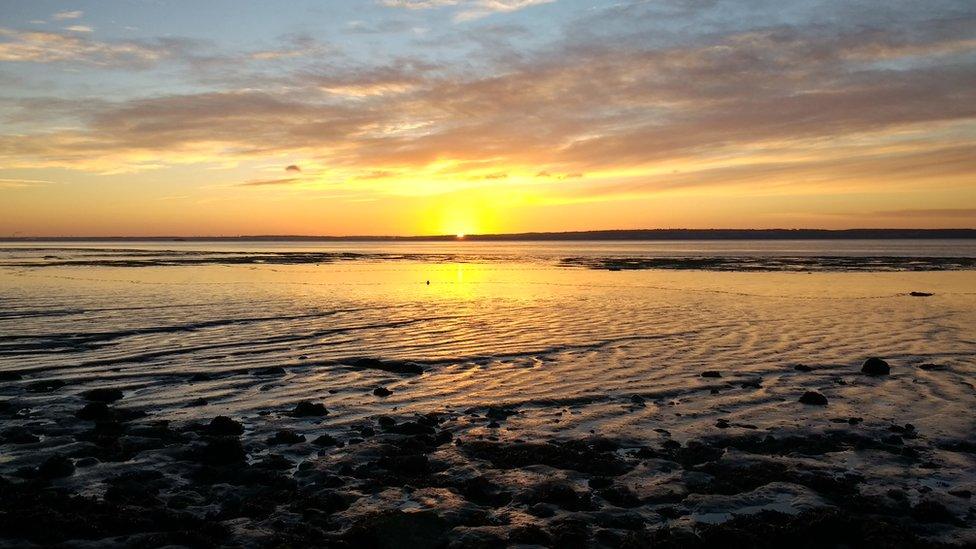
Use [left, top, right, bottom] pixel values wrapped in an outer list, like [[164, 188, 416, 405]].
[[0, 247, 976, 546]]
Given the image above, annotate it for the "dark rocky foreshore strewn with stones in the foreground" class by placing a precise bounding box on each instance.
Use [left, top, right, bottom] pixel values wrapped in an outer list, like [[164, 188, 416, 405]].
[[0, 359, 976, 548]]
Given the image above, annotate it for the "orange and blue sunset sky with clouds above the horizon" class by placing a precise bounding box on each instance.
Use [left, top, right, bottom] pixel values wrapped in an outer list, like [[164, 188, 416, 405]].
[[0, 0, 976, 237]]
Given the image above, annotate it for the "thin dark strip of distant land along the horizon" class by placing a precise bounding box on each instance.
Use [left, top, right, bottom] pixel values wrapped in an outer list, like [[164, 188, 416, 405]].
[[0, 229, 976, 242]]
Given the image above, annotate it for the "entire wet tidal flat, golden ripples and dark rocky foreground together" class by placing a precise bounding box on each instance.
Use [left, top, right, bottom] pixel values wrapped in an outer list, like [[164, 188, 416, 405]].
[[0, 246, 976, 547]]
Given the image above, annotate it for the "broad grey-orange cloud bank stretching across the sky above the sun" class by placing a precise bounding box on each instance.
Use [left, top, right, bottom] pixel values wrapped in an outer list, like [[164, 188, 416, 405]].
[[0, 0, 976, 210]]
